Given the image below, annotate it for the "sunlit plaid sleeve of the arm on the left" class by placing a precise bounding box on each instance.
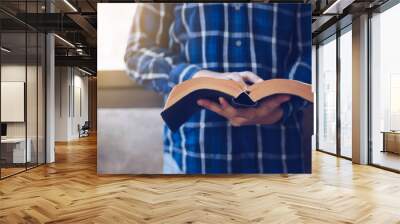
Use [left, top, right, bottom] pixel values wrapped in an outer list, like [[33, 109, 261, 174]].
[[125, 3, 200, 94]]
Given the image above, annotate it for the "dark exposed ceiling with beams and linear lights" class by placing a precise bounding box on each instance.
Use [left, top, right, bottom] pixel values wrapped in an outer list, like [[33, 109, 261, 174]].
[[0, 0, 394, 71]]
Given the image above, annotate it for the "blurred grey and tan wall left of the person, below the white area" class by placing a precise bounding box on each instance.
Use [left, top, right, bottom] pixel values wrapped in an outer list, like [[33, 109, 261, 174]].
[[97, 71, 163, 174]]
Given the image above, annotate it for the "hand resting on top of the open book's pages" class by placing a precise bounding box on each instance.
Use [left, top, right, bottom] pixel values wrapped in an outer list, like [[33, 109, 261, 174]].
[[193, 70, 264, 85]]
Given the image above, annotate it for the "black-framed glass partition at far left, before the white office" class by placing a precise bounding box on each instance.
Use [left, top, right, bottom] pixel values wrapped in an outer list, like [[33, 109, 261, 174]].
[[0, 1, 46, 179]]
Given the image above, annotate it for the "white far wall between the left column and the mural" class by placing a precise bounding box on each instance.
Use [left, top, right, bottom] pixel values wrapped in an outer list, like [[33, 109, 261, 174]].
[[55, 67, 88, 141]]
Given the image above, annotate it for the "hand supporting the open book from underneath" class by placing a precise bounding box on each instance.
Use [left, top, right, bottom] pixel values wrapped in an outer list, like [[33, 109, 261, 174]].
[[197, 94, 290, 126]]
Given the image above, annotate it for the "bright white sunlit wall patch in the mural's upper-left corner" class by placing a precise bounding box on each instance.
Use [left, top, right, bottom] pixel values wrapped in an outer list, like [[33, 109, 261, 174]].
[[97, 3, 136, 71]]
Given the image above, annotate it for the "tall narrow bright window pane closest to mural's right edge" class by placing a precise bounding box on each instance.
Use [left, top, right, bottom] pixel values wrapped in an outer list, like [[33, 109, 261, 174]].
[[318, 38, 336, 153]]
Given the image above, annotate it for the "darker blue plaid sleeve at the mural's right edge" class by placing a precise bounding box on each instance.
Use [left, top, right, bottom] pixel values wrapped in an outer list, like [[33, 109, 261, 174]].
[[281, 4, 311, 123]]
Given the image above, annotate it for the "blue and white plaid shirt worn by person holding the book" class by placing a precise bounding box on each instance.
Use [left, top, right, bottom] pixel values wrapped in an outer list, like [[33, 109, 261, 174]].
[[125, 3, 311, 174]]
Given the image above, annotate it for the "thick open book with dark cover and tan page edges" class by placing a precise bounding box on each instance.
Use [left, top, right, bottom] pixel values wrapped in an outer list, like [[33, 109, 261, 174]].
[[161, 77, 313, 131]]
